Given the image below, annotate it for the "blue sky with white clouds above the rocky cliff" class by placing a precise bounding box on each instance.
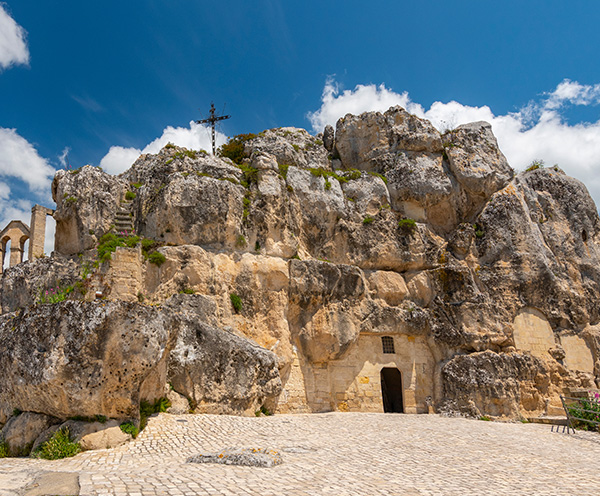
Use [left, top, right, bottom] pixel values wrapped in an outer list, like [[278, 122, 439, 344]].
[[0, 0, 600, 248]]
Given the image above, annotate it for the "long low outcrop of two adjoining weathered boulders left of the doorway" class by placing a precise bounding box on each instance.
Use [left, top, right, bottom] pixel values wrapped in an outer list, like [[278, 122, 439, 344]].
[[0, 301, 281, 424]]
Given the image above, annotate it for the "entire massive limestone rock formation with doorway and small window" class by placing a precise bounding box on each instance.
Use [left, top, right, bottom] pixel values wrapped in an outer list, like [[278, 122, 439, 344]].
[[0, 107, 600, 452]]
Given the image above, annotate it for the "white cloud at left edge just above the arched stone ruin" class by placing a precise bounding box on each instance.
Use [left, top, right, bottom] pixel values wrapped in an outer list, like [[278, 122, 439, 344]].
[[0, 127, 55, 193]]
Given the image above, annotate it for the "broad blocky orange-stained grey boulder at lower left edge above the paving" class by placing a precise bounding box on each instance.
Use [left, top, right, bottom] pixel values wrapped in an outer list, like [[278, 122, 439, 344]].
[[0, 301, 168, 419]]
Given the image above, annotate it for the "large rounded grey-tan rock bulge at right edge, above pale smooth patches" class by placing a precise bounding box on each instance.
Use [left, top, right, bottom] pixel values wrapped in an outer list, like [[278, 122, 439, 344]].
[[477, 169, 600, 329]]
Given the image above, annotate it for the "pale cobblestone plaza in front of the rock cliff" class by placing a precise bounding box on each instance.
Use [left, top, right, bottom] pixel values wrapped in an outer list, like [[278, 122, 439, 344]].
[[0, 413, 600, 496]]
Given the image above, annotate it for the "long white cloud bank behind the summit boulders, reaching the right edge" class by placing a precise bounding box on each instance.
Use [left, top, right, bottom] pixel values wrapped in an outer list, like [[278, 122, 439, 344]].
[[308, 79, 600, 204]]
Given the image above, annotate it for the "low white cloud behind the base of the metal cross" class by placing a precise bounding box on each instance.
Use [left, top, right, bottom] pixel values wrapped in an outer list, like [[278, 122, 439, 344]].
[[100, 121, 227, 174]]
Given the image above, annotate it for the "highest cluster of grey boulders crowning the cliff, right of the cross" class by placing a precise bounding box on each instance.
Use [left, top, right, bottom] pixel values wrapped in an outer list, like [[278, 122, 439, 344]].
[[335, 107, 513, 231]]
